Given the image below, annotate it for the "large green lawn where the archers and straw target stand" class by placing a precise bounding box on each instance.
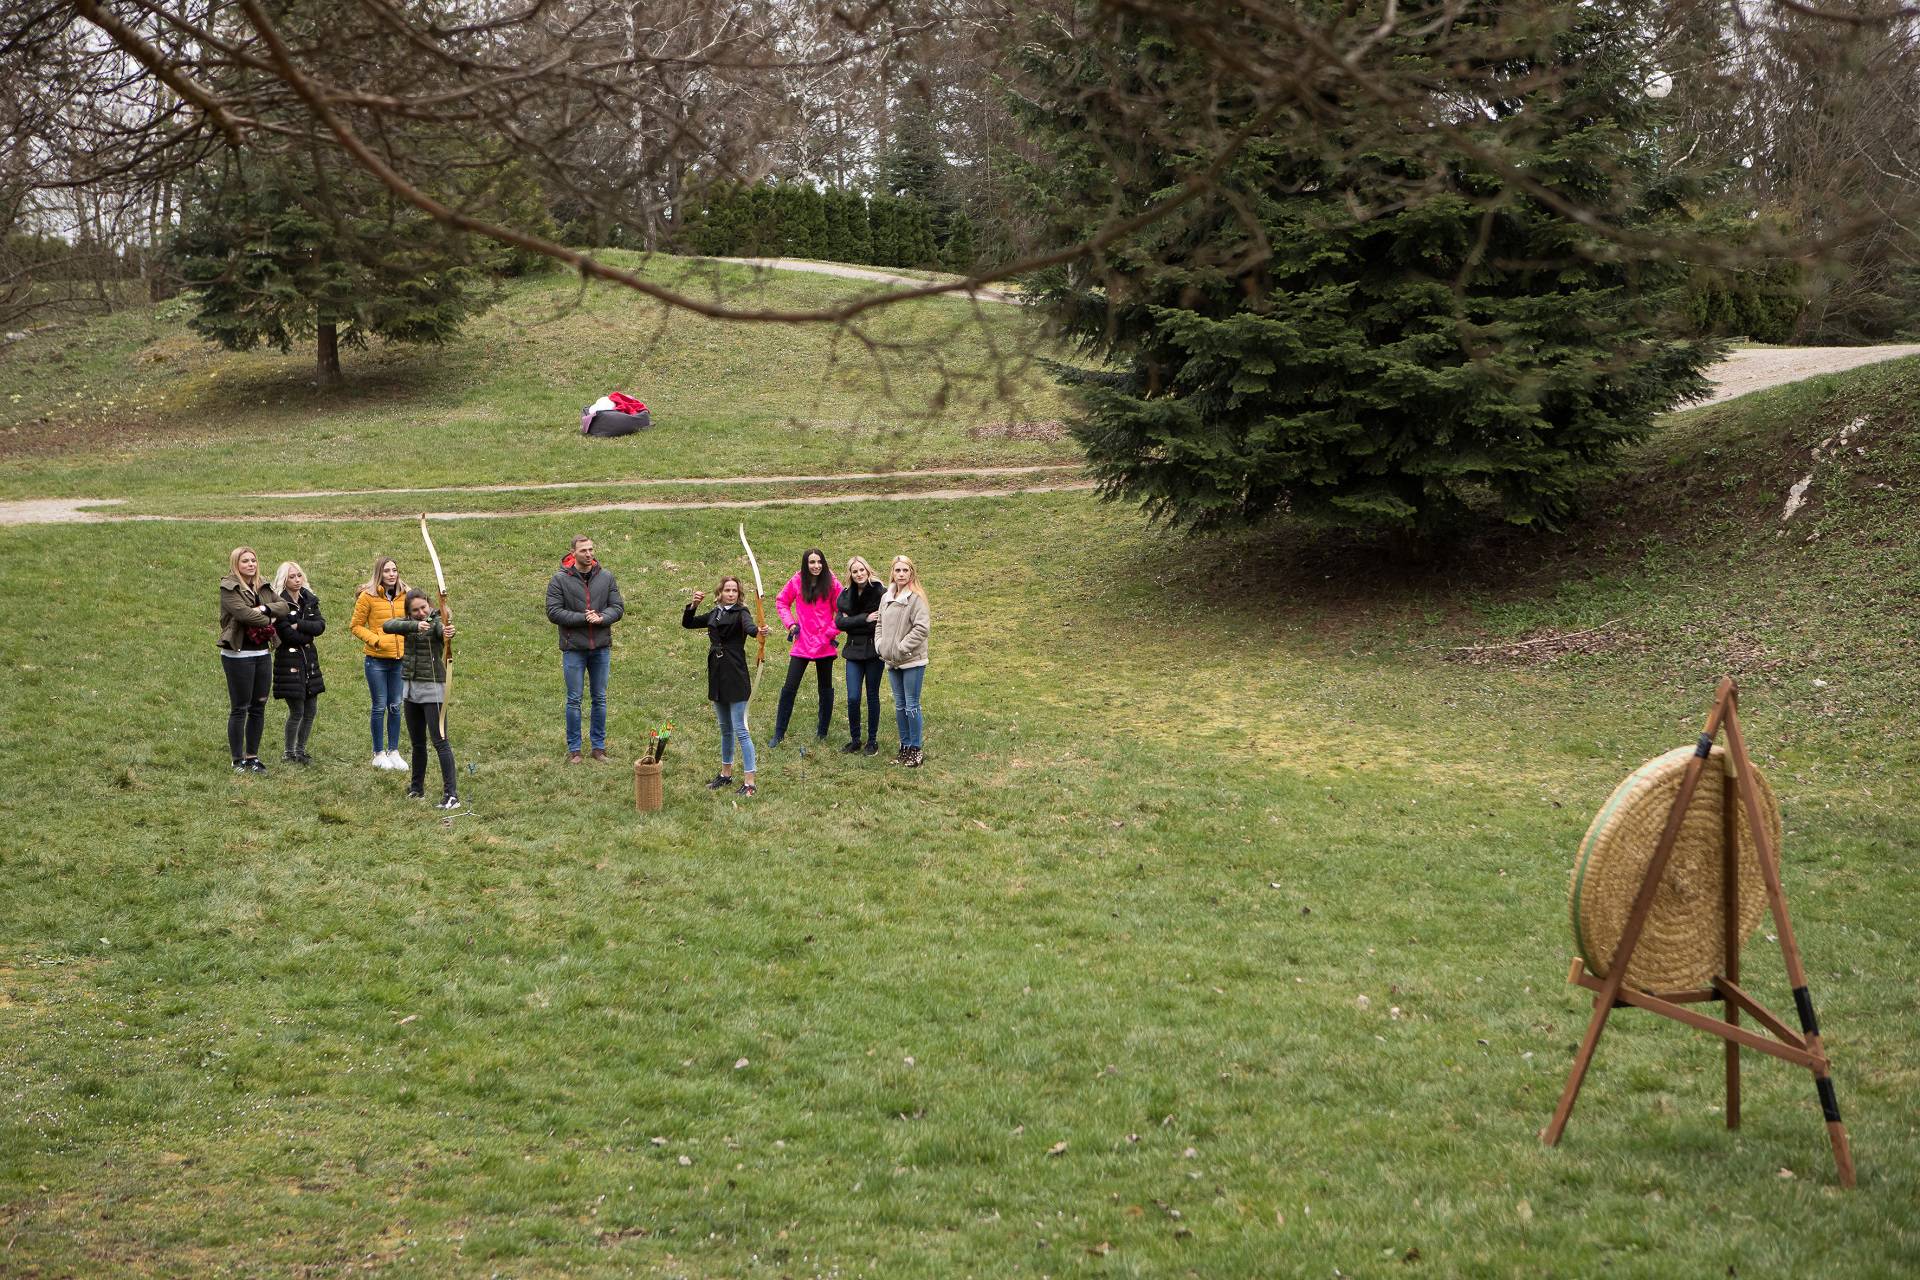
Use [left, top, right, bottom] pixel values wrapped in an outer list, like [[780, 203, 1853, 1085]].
[[0, 272, 1920, 1278]]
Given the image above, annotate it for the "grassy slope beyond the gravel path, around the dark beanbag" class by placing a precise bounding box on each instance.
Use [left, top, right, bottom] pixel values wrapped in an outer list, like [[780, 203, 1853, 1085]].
[[0, 253, 1077, 497]]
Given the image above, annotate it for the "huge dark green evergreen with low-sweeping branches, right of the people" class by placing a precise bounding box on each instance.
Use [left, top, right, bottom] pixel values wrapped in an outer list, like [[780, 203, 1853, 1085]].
[[1025, 0, 1711, 532]]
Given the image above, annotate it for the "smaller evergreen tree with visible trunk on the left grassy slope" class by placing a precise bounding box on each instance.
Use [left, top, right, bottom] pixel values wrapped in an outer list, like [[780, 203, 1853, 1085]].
[[173, 152, 509, 384]]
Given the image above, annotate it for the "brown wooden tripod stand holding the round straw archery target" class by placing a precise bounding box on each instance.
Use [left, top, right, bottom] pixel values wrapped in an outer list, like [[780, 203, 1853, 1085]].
[[1540, 677, 1855, 1186]]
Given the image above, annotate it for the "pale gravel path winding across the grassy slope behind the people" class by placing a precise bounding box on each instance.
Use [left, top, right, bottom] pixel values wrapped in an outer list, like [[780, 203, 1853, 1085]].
[[0, 339, 1920, 526]]
